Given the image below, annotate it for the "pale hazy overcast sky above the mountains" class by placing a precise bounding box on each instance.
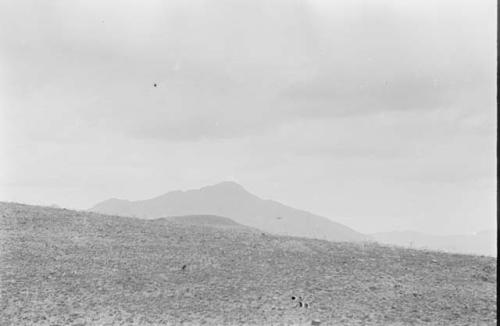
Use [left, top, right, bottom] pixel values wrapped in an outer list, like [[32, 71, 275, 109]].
[[0, 0, 497, 234]]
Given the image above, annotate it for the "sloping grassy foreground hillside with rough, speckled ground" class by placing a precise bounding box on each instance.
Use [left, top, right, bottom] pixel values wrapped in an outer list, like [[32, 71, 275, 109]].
[[0, 203, 497, 326]]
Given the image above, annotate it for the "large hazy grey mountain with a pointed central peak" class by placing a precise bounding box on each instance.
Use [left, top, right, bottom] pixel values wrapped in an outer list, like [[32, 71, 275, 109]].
[[90, 182, 368, 241]]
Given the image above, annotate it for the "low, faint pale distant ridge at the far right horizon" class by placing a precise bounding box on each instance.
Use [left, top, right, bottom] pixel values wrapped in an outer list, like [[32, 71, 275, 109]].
[[371, 230, 497, 256]]
